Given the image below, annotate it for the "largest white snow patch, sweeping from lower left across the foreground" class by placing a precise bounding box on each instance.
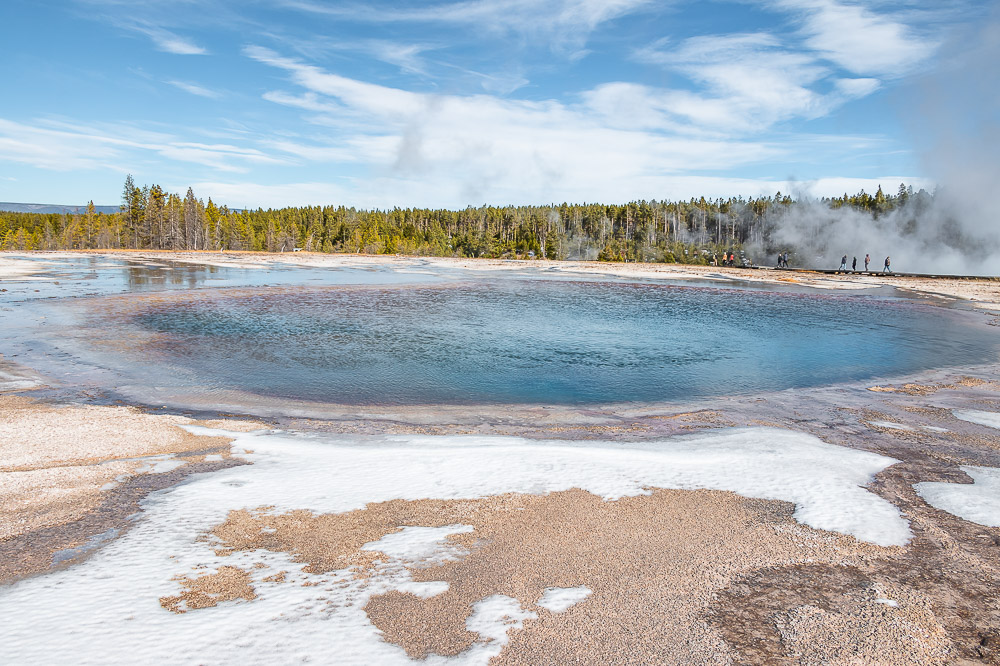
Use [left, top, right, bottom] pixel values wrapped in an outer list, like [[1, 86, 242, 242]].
[[0, 427, 916, 666]]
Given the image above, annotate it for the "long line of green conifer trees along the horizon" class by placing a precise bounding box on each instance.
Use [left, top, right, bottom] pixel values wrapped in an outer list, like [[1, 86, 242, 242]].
[[0, 176, 933, 263]]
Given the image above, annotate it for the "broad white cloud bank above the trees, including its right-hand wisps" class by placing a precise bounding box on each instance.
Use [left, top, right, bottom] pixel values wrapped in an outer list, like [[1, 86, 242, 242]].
[[238, 44, 932, 206]]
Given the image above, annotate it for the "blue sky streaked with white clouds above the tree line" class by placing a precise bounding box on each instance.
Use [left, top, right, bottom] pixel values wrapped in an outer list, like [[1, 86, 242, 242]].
[[0, 0, 990, 207]]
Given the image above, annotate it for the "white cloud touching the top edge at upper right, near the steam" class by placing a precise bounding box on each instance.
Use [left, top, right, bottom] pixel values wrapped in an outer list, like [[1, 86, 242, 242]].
[[775, 0, 938, 78]]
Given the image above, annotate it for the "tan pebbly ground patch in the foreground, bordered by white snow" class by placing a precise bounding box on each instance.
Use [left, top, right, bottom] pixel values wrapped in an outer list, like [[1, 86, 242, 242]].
[[209, 490, 916, 664]]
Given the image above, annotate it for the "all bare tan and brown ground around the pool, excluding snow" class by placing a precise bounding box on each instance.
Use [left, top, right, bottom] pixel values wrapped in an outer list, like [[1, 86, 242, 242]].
[[0, 253, 1000, 664]]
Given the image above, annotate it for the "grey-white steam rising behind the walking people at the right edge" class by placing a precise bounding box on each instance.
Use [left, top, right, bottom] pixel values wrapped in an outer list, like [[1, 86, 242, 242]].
[[768, 12, 1000, 275]]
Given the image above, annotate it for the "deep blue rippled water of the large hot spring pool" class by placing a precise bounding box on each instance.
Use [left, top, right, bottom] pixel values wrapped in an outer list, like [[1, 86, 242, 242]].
[[68, 275, 997, 404]]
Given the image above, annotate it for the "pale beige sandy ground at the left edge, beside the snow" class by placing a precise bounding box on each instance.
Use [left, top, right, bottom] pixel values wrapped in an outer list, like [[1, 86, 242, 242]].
[[0, 393, 262, 583]]
